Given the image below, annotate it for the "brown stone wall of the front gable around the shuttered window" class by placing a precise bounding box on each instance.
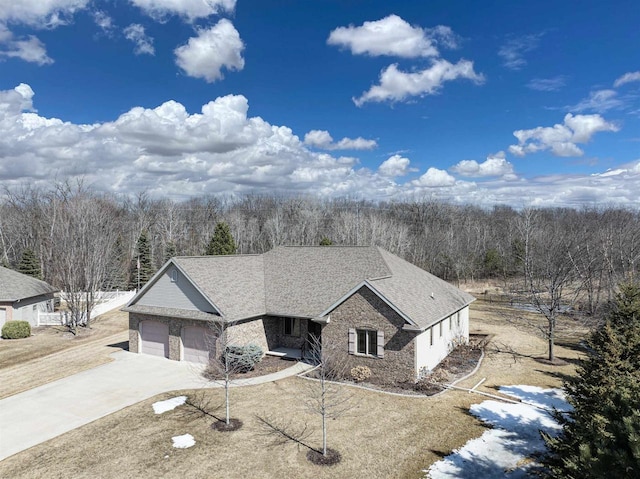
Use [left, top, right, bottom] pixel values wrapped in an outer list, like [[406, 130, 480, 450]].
[[322, 286, 416, 384]]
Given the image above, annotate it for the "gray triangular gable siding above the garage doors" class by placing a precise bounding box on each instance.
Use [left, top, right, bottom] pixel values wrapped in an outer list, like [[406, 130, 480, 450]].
[[136, 266, 215, 313]]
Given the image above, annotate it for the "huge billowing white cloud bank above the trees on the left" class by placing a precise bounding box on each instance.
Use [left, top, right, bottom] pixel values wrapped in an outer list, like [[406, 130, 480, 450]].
[[0, 84, 396, 197]]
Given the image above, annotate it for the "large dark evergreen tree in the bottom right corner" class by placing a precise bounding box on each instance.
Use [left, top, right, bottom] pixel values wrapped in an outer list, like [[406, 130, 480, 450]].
[[543, 285, 640, 479]]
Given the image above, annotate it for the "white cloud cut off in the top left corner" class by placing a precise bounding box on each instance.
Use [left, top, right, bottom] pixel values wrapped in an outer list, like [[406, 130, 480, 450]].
[[0, 0, 89, 28]]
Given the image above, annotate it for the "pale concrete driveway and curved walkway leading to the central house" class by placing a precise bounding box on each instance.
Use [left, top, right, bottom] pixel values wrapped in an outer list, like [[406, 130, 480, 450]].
[[0, 351, 309, 460]]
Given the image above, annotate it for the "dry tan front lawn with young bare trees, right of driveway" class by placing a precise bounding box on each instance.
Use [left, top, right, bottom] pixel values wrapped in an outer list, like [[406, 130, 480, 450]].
[[0, 302, 578, 479]]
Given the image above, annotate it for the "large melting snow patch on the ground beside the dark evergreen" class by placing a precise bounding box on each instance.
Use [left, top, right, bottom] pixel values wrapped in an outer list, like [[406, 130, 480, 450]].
[[424, 386, 570, 479]]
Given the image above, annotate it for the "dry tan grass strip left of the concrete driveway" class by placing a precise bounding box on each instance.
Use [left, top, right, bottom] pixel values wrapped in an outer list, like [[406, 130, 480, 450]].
[[0, 311, 129, 399]]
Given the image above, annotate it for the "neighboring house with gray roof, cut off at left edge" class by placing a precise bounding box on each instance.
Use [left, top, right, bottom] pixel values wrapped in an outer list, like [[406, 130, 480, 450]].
[[0, 266, 59, 327]]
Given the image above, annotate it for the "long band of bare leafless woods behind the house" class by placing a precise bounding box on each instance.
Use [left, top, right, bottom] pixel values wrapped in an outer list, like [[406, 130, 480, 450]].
[[0, 183, 640, 314]]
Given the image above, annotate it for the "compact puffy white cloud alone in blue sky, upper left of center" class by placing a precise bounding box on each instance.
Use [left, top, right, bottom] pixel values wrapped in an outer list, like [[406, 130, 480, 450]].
[[174, 19, 244, 83]]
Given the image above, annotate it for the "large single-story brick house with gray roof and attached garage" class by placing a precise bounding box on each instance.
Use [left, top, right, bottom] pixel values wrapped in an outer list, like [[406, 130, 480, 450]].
[[124, 246, 474, 382]]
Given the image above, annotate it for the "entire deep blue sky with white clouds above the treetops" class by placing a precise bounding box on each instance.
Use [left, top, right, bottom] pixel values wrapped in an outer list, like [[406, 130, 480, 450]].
[[0, 0, 640, 207]]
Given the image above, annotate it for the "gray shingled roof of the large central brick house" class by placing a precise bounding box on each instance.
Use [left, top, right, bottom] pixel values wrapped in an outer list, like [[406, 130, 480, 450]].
[[126, 246, 474, 329]]
